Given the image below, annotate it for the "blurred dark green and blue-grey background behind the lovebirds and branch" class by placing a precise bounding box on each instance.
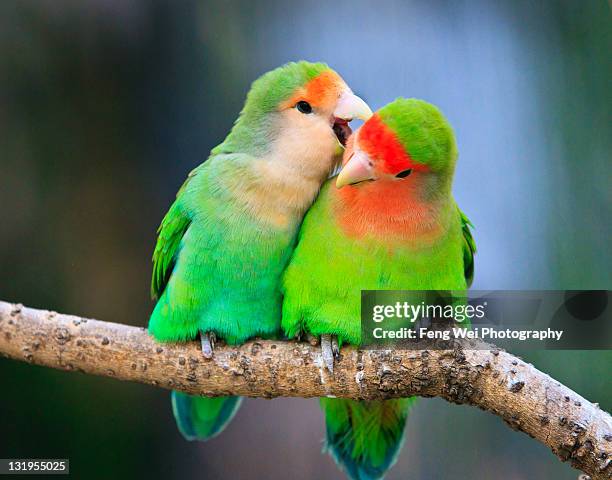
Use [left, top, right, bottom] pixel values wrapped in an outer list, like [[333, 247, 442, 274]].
[[0, 0, 612, 480]]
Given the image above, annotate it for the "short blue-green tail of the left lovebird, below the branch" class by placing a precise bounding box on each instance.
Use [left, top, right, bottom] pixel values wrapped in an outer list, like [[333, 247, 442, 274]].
[[172, 391, 242, 442]]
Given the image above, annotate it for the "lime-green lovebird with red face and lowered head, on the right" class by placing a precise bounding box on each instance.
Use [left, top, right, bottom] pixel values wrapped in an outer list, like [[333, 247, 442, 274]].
[[282, 98, 476, 480]]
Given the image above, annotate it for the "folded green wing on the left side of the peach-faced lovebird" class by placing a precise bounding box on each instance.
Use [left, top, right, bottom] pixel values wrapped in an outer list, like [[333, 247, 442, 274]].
[[151, 164, 204, 300]]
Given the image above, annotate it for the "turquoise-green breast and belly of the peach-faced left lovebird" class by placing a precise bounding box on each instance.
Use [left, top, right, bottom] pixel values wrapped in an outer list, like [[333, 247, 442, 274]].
[[149, 158, 300, 343]]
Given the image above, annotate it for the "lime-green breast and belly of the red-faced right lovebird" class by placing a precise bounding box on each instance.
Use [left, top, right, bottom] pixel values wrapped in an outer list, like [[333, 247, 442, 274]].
[[283, 181, 466, 343]]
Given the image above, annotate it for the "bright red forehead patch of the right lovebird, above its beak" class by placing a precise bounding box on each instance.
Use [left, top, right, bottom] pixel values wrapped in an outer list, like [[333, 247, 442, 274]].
[[358, 113, 427, 175]]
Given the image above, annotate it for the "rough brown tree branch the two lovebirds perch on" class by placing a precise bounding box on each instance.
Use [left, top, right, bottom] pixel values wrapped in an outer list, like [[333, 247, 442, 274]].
[[0, 302, 612, 479]]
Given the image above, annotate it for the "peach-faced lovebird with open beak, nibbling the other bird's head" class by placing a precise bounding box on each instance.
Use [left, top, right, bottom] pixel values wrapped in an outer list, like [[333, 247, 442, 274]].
[[149, 62, 372, 440]]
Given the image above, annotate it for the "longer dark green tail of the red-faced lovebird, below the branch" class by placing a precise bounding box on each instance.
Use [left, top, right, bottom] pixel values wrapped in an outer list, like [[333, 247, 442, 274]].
[[321, 397, 416, 480]]
